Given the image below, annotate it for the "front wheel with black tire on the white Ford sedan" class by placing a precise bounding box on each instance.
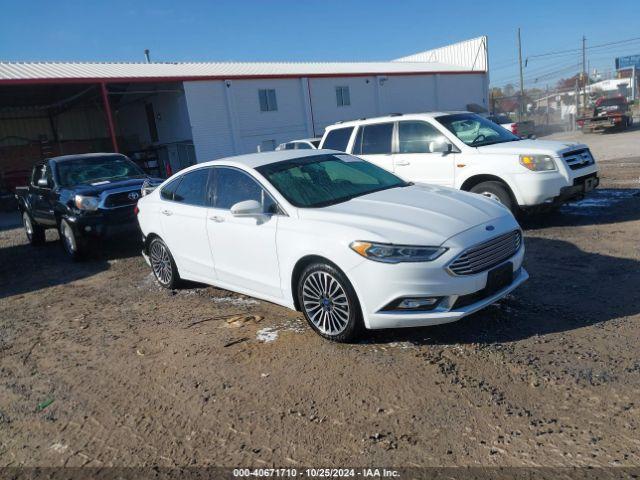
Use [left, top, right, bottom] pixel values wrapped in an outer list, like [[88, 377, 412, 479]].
[[298, 263, 362, 342]]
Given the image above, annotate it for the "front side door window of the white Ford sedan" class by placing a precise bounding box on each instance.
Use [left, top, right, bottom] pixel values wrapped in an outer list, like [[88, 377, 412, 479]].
[[214, 167, 276, 213]]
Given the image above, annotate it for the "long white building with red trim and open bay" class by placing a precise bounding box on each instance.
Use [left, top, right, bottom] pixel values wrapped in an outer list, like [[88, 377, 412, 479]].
[[0, 37, 489, 182]]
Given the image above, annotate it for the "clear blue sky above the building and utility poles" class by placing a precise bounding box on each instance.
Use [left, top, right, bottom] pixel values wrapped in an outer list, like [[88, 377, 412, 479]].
[[0, 0, 640, 88]]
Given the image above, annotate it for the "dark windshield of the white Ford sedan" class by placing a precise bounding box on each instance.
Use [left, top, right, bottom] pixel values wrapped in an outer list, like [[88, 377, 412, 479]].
[[256, 154, 410, 208]]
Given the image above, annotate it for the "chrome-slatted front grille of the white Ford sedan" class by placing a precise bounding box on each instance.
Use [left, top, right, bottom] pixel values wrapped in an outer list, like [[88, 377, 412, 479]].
[[449, 230, 522, 275]]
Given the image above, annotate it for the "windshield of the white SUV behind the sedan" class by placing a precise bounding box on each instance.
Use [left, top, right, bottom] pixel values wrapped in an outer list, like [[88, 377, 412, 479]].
[[435, 113, 520, 147]]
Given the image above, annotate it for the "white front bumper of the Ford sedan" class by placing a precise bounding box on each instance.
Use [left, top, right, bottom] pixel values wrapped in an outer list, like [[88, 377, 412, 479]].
[[346, 220, 529, 329]]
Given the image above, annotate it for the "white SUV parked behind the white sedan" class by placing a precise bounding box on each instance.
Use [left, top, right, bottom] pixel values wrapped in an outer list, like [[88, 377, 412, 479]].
[[320, 112, 599, 212]]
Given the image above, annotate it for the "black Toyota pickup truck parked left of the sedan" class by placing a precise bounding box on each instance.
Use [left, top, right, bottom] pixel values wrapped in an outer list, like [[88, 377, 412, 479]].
[[16, 153, 162, 259]]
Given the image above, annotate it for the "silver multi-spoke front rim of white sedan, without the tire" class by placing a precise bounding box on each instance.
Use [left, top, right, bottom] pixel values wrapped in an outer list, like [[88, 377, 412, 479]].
[[302, 271, 350, 336]]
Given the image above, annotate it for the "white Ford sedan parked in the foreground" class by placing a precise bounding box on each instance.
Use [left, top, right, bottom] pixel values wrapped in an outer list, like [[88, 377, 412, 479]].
[[138, 150, 528, 341]]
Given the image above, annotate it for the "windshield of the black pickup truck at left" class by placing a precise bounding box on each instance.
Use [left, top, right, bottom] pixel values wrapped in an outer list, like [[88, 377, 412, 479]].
[[56, 155, 146, 187]]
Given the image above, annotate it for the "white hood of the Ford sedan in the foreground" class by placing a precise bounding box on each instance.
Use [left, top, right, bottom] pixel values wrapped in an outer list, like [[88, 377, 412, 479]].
[[300, 184, 517, 246]]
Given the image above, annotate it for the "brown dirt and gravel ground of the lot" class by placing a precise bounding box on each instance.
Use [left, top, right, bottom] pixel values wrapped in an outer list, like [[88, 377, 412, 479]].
[[0, 130, 640, 467]]
